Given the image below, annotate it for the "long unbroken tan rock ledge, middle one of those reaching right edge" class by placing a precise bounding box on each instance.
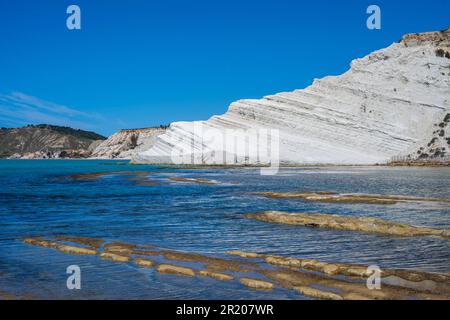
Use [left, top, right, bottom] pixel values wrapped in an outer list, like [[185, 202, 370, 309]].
[[245, 211, 450, 238]]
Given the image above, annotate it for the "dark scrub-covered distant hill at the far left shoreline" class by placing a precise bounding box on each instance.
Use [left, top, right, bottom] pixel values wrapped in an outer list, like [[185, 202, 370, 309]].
[[0, 124, 106, 159]]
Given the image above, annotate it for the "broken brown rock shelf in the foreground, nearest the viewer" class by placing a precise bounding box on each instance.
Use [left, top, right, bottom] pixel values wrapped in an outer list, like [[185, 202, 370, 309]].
[[24, 236, 450, 300]]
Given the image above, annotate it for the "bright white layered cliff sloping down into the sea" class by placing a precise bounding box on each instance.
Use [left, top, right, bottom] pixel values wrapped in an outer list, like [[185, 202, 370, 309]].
[[133, 28, 450, 164]]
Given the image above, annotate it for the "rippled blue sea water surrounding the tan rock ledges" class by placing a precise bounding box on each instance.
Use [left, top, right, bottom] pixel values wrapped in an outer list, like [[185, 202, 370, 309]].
[[0, 160, 450, 299]]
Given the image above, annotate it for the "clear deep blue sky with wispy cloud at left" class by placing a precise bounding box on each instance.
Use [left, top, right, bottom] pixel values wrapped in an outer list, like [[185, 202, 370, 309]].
[[0, 0, 450, 135]]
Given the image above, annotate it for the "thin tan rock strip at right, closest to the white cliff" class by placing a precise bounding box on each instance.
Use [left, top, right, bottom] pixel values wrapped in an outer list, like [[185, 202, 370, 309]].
[[255, 192, 450, 205]]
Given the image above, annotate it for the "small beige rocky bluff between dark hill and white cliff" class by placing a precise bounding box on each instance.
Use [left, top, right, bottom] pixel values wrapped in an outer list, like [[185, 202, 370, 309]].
[[91, 126, 166, 159]]
